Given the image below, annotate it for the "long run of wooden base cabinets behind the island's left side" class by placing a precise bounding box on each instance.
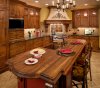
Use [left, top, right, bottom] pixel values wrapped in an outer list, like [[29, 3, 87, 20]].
[[9, 36, 51, 58]]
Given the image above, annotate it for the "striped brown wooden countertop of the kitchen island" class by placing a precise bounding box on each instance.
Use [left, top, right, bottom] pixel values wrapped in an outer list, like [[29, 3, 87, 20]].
[[7, 39, 86, 83]]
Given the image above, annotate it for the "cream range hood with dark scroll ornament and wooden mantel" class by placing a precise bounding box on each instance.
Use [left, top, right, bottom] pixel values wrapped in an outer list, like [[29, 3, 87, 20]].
[[45, 8, 71, 25]]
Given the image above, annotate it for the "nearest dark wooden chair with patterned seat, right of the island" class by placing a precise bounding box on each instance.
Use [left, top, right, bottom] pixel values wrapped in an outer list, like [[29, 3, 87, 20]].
[[72, 54, 88, 88]]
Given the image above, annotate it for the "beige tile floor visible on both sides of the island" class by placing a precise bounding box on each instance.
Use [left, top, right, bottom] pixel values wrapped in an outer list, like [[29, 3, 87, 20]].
[[0, 52, 100, 88]]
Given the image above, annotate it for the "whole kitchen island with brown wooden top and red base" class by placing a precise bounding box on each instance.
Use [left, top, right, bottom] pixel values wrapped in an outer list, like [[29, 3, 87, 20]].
[[7, 39, 86, 88]]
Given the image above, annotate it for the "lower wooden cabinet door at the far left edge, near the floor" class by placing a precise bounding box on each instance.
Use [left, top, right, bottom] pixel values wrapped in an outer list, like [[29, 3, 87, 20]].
[[0, 45, 7, 68]]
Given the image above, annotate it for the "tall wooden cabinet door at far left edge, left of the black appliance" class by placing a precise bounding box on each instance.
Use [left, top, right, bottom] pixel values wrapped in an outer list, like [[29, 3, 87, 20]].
[[0, 10, 7, 43]]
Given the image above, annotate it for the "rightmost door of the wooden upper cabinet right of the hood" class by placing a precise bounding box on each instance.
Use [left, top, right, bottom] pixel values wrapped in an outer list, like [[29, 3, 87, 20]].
[[89, 9, 98, 27]]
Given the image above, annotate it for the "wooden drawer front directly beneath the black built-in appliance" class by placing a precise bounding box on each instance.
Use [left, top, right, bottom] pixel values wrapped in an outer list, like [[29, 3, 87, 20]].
[[9, 29, 24, 40]]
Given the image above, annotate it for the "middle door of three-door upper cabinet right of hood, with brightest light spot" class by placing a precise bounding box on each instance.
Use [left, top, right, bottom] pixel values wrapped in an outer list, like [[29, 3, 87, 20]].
[[81, 10, 89, 27]]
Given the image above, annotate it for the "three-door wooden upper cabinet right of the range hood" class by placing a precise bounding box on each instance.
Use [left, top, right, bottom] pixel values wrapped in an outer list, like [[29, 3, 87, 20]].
[[73, 9, 98, 28]]
